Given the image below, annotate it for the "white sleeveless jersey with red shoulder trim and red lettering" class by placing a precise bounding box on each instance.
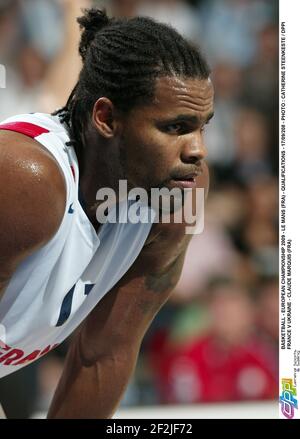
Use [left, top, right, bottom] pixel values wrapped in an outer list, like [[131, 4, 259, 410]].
[[0, 113, 153, 377]]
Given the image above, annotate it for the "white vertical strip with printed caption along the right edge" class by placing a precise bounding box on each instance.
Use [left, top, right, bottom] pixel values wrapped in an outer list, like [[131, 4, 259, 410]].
[[279, 0, 300, 419]]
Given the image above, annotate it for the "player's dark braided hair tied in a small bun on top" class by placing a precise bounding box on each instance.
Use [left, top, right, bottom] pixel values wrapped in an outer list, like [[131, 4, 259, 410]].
[[53, 9, 210, 168]]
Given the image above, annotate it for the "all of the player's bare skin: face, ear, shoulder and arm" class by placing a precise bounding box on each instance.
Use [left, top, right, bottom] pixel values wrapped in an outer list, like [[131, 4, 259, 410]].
[[0, 77, 213, 418]]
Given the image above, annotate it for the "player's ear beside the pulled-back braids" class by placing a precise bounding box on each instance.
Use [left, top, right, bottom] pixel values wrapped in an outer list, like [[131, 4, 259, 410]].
[[92, 97, 117, 139]]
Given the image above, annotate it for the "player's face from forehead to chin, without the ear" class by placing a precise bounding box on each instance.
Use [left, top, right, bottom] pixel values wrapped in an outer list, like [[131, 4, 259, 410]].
[[118, 77, 213, 190]]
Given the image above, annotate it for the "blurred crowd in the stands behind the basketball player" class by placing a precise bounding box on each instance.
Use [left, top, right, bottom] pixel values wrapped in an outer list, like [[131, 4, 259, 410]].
[[0, 0, 278, 418]]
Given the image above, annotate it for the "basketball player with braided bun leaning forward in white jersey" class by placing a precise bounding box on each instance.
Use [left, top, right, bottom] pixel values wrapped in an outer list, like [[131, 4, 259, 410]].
[[0, 9, 213, 418]]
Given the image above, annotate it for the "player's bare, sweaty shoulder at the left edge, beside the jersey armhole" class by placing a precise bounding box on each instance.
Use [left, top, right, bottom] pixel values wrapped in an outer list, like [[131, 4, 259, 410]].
[[0, 131, 66, 269]]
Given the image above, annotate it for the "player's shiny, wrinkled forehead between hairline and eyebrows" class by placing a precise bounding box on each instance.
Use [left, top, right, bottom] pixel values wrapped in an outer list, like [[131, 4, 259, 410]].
[[153, 77, 214, 116]]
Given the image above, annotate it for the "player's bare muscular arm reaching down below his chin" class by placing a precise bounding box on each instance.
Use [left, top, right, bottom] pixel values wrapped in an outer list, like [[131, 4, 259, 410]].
[[48, 162, 208, 418]]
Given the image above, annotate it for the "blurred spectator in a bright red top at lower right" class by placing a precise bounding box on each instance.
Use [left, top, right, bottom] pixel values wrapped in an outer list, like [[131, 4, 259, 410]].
[[152, 282, 278, 403]]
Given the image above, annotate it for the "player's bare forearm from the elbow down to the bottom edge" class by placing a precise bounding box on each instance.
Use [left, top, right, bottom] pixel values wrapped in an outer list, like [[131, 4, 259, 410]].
[[48, 339, 139, 419]]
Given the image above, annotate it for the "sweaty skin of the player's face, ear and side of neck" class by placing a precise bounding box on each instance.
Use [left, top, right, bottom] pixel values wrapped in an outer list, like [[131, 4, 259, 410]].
[[80, 77, 213, 227]]
